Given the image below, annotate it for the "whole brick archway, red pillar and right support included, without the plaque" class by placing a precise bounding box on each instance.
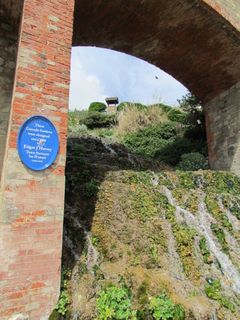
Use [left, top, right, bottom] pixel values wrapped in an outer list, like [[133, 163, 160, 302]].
[[0, 0, 240, 319]]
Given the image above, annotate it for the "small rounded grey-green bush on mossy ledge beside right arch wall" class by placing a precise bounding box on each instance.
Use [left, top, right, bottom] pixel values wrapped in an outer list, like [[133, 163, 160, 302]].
[[177, 152, 207, 171]]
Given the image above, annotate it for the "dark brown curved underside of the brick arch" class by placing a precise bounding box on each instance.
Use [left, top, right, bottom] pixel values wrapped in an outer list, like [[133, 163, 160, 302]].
[[73, 0, 240, 102]]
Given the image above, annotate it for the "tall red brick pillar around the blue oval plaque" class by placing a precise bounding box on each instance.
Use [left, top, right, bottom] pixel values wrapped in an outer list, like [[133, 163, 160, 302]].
[[0, 0, 74, 320]]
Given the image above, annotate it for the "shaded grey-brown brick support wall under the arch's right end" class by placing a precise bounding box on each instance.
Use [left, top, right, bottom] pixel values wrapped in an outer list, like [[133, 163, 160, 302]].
[[205, 82, 240, 175]]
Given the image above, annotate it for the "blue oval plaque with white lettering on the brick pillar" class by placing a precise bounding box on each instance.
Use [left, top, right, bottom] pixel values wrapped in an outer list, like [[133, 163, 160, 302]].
[[17, 115, 59, 171]]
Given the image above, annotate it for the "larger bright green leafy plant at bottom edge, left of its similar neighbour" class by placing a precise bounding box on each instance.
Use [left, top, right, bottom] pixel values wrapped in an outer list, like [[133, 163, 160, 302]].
[[97, 285, 136, 320]]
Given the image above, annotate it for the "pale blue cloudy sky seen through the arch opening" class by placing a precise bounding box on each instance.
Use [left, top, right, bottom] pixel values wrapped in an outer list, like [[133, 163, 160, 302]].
[[70, 47, 187, 110]]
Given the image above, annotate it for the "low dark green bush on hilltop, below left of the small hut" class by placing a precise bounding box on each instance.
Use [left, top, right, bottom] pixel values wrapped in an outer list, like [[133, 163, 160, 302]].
[[79, 112, 116, 129]]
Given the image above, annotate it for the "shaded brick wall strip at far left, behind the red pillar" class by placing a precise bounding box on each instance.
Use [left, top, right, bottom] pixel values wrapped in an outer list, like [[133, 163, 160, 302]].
[[0, 17, 18, 177]]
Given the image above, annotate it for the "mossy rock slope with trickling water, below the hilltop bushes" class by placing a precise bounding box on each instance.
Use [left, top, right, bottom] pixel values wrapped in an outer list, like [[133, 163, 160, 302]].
[[57, 137, 240, 320]]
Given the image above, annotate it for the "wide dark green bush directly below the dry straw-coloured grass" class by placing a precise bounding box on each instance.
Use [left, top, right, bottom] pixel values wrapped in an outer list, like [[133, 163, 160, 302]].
[[123, 122, 176, 158]]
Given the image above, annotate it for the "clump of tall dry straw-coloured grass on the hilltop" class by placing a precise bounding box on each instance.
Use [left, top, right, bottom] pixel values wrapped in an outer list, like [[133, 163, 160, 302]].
[[116, 104, 168, 136]]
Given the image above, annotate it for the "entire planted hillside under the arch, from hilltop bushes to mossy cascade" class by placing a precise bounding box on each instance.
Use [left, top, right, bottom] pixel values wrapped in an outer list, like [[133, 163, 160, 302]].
[[63, 96, 240, 320]]
